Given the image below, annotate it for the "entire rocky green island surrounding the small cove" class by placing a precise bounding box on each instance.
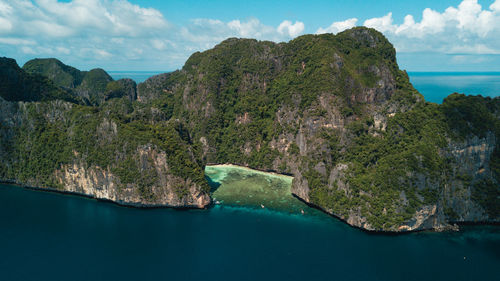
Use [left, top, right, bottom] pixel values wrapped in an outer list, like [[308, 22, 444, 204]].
[[0, 27, 500, 232]]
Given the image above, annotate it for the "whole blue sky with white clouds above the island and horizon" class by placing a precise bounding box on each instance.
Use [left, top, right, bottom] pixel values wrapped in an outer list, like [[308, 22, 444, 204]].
[[0, 0, 500, 71]]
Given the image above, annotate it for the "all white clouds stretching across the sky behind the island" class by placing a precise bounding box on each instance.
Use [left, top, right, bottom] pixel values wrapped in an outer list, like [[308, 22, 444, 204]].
[[0, 0, 500, 70]]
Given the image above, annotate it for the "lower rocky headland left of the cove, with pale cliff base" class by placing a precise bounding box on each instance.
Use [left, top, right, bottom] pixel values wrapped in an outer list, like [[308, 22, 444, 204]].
[[0, 73, 211, 208]]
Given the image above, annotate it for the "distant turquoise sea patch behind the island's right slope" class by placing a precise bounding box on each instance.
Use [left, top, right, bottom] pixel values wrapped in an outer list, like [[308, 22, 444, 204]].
[[408, 72, 500, 103]]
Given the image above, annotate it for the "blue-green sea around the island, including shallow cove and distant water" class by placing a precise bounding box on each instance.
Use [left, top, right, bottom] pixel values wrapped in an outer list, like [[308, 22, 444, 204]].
[[0, 72, 500, 281]]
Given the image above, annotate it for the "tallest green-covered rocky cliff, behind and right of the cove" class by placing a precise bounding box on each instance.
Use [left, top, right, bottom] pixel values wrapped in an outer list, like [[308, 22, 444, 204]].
[[135, 28, 499, 231]]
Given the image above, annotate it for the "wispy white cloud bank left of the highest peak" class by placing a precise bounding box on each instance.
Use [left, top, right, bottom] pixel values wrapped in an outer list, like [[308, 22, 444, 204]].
[[0, 0, 304, 69]]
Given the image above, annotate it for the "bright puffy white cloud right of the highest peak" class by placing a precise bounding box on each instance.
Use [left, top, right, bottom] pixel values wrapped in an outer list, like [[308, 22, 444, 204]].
[[356, 0, 500, 54]]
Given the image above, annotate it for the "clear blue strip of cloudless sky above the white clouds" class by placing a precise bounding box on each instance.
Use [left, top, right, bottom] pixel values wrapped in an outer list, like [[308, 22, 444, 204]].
[[131, 0, 460, 30]]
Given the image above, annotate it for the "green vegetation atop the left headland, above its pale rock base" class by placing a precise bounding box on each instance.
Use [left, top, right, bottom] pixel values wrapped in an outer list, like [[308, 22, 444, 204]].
[[4, 94, 208, 198]]
